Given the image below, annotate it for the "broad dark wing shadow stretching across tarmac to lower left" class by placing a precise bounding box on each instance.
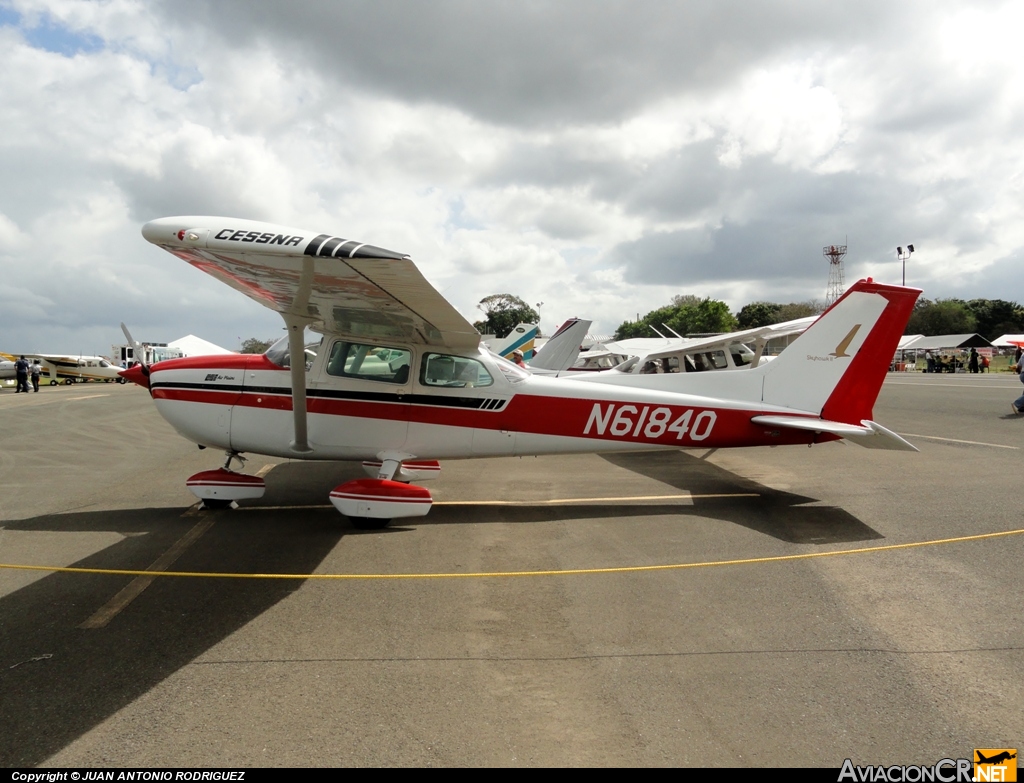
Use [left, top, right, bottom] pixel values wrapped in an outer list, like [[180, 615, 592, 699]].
[[0, 466, 360, 768]]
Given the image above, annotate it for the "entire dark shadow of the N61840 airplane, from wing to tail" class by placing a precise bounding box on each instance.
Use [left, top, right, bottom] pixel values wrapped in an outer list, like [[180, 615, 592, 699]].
[[0, 451, 881, 768]]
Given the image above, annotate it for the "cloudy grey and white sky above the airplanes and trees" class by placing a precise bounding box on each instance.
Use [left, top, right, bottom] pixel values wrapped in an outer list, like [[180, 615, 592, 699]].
[[0, 0, 1024, 353]]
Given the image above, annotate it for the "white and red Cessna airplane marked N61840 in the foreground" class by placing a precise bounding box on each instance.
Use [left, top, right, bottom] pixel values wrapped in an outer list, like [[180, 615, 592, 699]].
[[123, 217, 920, 529]]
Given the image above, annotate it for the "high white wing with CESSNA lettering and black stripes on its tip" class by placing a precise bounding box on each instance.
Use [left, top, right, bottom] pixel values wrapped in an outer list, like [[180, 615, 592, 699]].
[[142, 217, 480, 349]]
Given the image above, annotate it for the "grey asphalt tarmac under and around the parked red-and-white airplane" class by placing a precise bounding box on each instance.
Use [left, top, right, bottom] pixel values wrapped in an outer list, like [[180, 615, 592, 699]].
[[0, 375, 1024, 768]]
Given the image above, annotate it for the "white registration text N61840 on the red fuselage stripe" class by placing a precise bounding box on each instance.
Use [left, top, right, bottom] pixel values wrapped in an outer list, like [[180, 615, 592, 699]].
[[583, 402, 718, 442]]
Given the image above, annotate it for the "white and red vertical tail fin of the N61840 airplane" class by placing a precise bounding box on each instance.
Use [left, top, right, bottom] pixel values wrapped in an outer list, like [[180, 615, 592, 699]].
[[762, 277, 921, 425]]
